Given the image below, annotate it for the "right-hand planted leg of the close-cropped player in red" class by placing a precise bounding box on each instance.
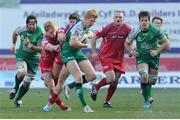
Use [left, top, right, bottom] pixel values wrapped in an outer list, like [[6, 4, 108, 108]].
[[103, 71, 121, 108]]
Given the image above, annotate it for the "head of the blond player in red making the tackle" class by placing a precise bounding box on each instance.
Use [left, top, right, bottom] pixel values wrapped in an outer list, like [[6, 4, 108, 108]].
[[44, 21, 58, 38]]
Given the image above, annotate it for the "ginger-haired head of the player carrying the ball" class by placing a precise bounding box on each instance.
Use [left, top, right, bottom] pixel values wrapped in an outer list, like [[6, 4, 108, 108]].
[[84, 9, 98, 28]]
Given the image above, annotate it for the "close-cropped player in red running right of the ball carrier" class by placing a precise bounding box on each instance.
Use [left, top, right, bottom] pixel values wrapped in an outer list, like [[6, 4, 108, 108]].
[[91, 11, 131, 108]]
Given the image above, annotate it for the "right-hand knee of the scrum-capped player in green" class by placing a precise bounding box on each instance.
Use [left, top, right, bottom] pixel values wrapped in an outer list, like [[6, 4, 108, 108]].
[[23, 74, 34, 89]]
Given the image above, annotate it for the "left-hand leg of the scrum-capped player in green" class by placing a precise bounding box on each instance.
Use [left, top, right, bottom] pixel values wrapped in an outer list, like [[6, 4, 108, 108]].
[[9, 61, 27, 99]]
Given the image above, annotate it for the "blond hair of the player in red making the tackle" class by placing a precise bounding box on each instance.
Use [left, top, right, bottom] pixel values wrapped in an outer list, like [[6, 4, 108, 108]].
[[44, 21, 58, 32]]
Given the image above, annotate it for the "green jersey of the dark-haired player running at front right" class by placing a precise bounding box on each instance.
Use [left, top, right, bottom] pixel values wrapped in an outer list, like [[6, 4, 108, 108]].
[[128, 24, 164, 55]]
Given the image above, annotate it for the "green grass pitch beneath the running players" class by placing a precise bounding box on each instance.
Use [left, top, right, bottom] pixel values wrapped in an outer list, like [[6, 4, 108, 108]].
[[0, 88, 180, 119]]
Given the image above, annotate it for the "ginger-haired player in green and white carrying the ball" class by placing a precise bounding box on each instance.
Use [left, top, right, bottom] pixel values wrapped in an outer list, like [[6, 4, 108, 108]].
[[46, 9, 98, 112]]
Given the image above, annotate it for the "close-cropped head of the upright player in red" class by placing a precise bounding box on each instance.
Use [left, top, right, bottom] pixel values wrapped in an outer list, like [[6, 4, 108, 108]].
[[113, 11, 124, 26]]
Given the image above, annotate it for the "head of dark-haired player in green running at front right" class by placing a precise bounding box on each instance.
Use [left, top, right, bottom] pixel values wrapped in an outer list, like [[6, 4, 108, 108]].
[[139, 11, 150, 31]]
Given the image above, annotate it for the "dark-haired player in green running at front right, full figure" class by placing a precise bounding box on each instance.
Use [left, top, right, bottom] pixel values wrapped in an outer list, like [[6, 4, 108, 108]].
[[126, 11, 169, 108]]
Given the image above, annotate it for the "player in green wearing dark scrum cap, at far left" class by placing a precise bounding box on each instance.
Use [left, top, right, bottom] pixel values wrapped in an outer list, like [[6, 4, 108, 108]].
[[9, 15, 43, 107]]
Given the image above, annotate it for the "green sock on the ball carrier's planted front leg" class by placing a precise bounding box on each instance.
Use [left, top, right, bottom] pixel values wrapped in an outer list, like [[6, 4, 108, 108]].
[[76, 83, 87, 107]]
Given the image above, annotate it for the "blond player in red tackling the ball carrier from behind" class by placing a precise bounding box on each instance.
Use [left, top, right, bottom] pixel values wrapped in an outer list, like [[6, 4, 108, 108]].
[[39, 21, 70, 112]]
